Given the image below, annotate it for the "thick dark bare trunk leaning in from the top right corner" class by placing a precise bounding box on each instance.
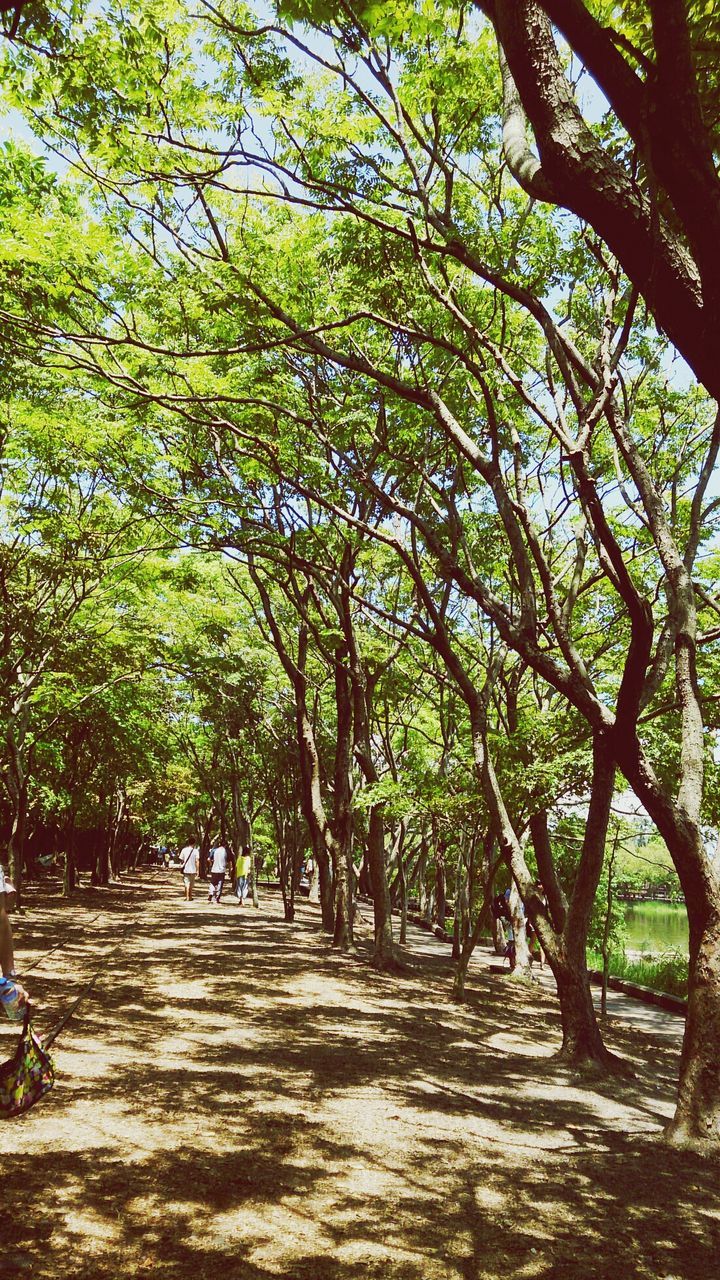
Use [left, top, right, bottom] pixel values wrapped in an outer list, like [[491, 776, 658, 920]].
[[478, 0, 720, 397]]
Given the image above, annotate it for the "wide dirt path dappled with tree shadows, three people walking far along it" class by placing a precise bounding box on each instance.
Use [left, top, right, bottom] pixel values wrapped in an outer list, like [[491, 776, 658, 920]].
[[0, 873, 720, 1280]]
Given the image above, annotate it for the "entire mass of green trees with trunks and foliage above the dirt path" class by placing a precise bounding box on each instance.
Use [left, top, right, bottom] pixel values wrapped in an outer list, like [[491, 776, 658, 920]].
[[0, 0, 720, 1148]]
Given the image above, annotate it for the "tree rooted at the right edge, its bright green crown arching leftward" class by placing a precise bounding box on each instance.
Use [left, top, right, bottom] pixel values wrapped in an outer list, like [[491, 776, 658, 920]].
[[4, 5, 720, 1147]]
